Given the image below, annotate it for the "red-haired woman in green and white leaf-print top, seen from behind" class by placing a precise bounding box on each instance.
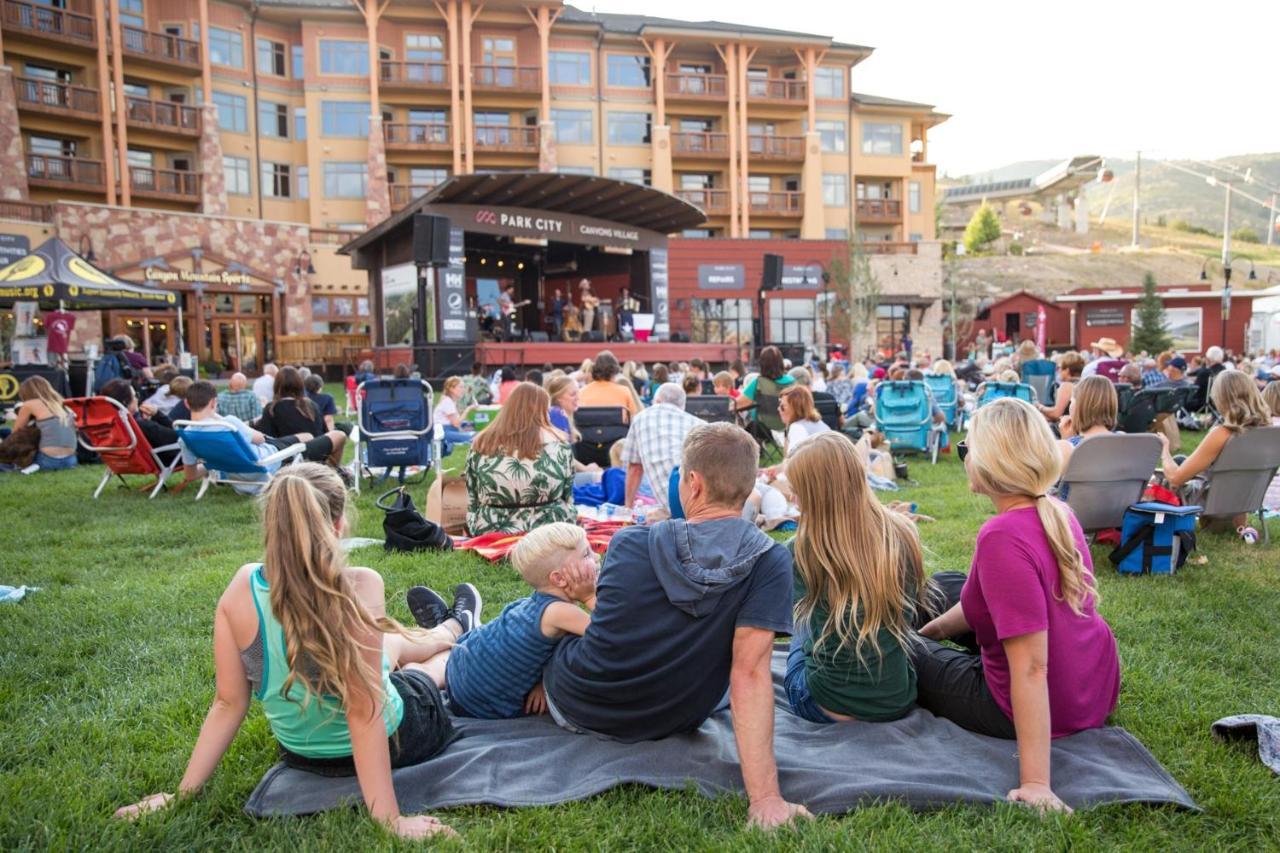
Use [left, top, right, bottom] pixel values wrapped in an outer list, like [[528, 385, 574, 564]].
[[466, 382, 577, 535]]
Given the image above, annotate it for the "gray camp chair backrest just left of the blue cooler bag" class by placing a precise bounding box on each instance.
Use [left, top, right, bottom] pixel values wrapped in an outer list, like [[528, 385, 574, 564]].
[[1059, 433, 1161, 533]]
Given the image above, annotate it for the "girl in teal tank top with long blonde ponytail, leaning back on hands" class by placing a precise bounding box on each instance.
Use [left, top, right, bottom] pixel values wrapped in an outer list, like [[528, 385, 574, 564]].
[[116, 462, 456, 839]]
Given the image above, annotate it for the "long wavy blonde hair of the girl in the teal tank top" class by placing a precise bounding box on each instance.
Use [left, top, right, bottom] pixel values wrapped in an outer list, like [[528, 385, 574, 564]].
[[261, 462, 411, 713]]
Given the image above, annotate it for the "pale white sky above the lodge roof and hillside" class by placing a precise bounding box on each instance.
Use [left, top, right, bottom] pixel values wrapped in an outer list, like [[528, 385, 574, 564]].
[[586, 0, 1280, 175]]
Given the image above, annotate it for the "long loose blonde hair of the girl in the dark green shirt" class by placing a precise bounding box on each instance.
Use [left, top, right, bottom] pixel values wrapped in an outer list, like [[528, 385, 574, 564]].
[[787, 433, 928, 666]]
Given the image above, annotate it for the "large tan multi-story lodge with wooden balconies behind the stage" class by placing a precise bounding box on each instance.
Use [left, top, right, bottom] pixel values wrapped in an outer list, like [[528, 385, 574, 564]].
[[0, 0, 947, 370]]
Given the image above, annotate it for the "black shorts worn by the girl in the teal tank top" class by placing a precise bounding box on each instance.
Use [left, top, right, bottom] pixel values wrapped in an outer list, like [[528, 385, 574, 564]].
[[280, 670, 458, 776]]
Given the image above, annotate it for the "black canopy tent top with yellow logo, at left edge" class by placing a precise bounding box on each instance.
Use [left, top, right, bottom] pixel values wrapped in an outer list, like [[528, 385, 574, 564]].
[[0, 237, 178, 311]]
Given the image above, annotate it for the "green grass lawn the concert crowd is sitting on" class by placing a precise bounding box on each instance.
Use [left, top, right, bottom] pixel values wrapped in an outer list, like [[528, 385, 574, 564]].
[[0, 397, 1280, 850]]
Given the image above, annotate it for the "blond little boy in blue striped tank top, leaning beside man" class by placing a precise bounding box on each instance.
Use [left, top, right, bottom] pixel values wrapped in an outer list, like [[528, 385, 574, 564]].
[[407, 521, 598, 720]]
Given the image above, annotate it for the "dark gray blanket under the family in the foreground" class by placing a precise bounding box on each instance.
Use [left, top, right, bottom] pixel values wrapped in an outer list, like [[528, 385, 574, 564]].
[[244, 652, 1197, 817]]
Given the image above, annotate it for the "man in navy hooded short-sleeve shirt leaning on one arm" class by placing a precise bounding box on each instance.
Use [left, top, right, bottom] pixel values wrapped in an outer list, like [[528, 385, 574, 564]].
[[544, 424, 808, 827]]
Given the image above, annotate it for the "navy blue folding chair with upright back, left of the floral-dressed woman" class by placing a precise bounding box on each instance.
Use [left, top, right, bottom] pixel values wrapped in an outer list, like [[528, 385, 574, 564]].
[[356, 378, 434, 494]]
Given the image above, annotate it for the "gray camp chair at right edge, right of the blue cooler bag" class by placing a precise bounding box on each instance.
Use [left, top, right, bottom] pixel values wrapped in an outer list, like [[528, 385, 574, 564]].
[[1197, 427, 1280, 542]]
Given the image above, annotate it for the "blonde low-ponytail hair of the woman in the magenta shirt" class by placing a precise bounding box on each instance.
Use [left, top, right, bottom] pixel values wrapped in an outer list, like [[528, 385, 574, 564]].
[[962, 397, 1100, 616]]
